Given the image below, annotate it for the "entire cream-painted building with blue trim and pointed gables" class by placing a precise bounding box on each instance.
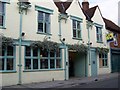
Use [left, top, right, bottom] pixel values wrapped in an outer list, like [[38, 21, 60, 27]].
[[0, 0, 118, 86]]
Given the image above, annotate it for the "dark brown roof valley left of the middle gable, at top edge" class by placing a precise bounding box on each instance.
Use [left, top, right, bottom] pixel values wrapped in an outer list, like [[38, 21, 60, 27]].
[[53, 0, 73, 14]]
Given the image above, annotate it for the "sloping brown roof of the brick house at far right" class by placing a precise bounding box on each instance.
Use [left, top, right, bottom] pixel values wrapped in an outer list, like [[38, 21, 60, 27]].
[[103, 17, 120, 33]]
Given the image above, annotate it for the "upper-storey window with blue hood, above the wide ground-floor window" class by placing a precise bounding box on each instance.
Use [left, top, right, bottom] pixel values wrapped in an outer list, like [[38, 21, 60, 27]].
[[35, 6, 53, 34]]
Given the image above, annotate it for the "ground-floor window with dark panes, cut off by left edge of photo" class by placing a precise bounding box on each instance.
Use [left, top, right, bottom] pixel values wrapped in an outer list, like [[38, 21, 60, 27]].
[[0, 46, 15, 71]]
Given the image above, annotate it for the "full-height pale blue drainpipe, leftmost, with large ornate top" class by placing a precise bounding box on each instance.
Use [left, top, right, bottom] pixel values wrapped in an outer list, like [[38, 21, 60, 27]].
[[17, 0, 31, 85]]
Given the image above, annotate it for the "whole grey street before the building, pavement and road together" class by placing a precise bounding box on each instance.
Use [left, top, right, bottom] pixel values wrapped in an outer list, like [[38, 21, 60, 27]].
[[3, 73, 120, 90]]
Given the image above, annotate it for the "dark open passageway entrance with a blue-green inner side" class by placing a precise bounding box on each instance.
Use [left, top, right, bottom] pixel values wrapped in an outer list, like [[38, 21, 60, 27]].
[[69, 52, 87, 78]]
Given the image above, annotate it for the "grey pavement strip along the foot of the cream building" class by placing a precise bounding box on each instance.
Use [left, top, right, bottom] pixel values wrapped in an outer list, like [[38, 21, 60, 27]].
[[3, 73, 118, 88]]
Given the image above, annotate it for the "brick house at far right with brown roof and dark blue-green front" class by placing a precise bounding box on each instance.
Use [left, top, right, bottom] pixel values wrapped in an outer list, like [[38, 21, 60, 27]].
[[103, 2, 120, 72]]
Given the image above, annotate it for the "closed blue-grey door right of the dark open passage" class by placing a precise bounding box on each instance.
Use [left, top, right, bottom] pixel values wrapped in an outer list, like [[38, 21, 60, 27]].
[[91, 49, 97, 77]]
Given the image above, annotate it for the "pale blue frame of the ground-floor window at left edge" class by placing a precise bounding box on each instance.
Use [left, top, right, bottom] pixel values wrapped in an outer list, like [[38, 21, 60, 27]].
[[0, 46, 16, 72]]
